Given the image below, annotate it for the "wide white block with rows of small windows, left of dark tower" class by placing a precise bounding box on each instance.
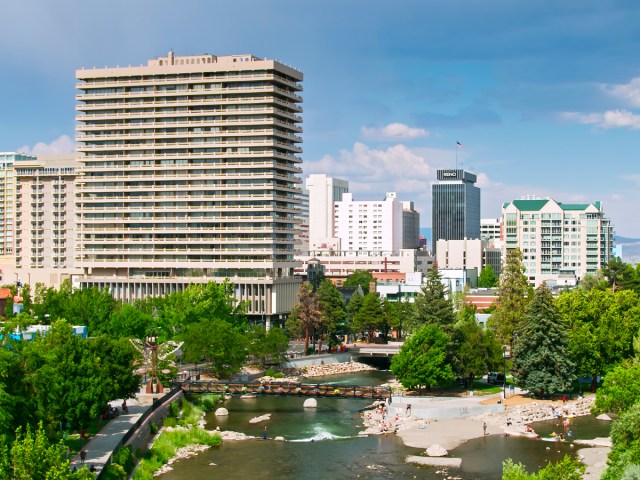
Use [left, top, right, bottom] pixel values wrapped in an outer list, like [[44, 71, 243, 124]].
[[335, 193, 402, 252]]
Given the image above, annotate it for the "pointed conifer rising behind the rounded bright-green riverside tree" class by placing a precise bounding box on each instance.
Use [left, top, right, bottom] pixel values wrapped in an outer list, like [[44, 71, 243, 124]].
[[415, 267, 456, 333]]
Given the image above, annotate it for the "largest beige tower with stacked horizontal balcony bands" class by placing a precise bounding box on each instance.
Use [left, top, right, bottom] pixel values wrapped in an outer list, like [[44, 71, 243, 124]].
[[76, 52, 303, 321]]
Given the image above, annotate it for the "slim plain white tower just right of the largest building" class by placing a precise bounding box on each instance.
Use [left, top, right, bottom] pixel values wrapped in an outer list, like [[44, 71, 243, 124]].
[[306, 174, 349, 250]]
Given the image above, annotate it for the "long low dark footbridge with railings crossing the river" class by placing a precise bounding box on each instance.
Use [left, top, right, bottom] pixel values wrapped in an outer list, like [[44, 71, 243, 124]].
[[176, 377, 391, 400]]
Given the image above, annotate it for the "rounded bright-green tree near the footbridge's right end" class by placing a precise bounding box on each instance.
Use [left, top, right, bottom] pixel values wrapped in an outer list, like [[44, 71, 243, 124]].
[[391, 325, 454, 389]]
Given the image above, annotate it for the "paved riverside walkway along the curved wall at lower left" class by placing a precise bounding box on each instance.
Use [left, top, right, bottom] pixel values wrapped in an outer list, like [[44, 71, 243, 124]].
[[71, 394, 158, 472]]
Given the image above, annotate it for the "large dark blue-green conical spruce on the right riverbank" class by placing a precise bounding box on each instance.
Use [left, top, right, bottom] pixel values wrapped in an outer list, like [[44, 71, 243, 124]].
[[514, 283, 574, 397]]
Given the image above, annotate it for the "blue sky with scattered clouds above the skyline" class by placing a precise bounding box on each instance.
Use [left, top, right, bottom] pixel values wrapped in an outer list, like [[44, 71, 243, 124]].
[[0, 0, 640, 237]]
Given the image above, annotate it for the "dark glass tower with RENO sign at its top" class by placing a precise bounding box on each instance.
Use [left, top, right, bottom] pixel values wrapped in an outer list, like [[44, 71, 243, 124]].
[[431, 170, 480, 252]]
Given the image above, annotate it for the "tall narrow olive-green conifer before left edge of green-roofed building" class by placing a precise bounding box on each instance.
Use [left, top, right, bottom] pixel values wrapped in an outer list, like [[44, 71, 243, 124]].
[[487, 248, 530, 352]]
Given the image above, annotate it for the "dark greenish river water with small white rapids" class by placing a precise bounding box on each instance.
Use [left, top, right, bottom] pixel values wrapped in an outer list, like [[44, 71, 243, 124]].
[[161, 372, 609, 480]]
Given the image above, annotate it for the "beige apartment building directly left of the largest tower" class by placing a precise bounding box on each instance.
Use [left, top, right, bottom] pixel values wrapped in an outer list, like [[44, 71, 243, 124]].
[[13, 154, 78, 288]]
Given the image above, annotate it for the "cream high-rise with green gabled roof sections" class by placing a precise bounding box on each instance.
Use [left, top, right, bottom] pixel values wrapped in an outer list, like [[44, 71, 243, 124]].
[[502, 199, 613, 286]]
